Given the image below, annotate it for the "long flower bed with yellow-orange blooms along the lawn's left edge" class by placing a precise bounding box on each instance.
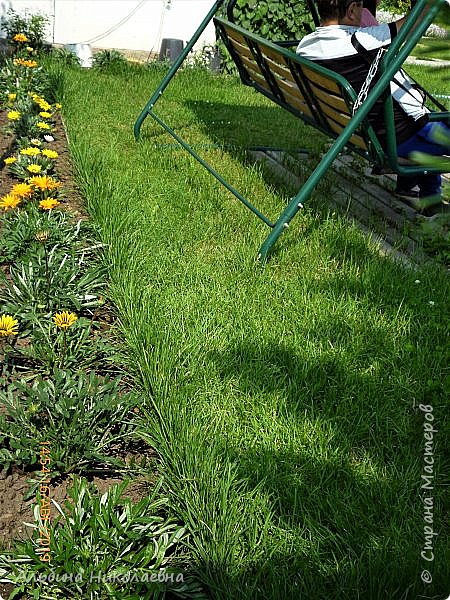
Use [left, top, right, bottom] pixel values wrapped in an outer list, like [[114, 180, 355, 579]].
[[0, 16, 197, 598]]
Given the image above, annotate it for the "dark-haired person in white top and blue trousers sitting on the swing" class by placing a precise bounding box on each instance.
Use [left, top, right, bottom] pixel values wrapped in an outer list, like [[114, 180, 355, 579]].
[[297, 0, 450, 216]]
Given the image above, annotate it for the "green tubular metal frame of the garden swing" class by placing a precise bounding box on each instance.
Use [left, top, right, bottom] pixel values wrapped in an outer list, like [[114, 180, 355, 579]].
[[134, 0, 450, 261]]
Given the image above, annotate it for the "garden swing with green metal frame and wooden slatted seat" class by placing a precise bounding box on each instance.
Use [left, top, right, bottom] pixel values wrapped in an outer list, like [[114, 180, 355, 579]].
[[134, 0, 450, 261]]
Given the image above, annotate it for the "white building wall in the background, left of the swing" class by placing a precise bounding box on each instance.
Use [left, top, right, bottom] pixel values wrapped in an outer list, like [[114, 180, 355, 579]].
[[0, 0, 215, 52]]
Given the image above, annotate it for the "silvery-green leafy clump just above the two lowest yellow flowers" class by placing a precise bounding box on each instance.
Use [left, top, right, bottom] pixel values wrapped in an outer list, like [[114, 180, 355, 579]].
[[0, 209, 105, 320]]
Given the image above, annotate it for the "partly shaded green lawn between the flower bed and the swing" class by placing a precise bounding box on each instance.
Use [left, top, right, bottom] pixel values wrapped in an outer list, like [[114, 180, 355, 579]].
[[63, 62, 450, 600]]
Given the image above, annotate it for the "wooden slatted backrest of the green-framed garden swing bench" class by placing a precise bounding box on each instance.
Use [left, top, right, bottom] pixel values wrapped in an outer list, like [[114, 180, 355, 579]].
[[214, 17, 387, 168]]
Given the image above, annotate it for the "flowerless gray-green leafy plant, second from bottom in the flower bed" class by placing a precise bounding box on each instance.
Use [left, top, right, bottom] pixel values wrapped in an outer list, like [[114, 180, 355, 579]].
[[0, 369, 137, 474]]
